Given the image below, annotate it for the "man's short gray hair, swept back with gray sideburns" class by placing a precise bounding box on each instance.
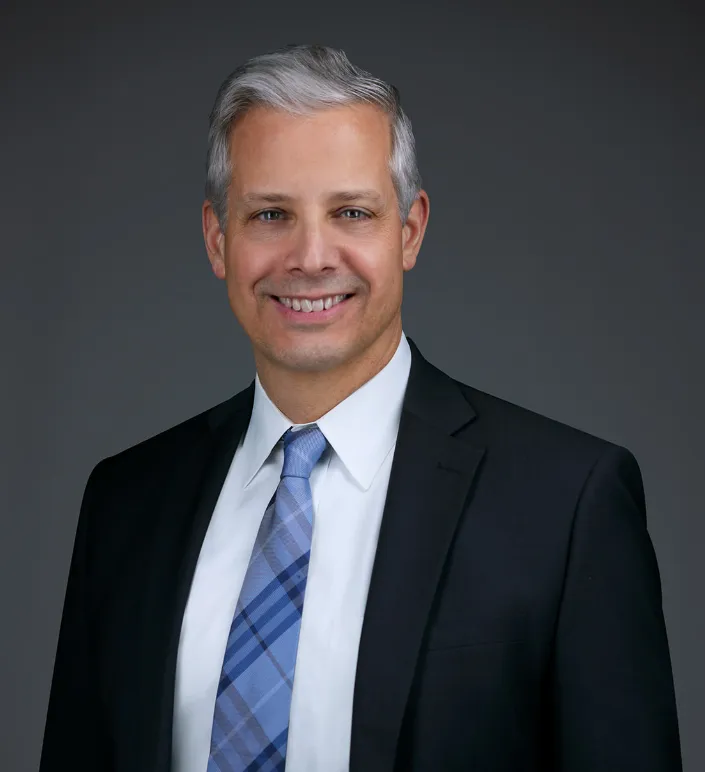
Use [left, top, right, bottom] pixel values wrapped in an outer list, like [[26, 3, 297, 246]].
[[206, 45, 421, 230]]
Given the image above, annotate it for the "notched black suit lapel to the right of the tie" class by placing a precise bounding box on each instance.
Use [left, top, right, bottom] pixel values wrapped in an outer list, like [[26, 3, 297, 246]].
[[350, 340, 484, 772]]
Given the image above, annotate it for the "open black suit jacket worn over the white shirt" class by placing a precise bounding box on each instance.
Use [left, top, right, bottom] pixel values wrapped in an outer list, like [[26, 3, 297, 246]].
[[41, 341, 681, 772]]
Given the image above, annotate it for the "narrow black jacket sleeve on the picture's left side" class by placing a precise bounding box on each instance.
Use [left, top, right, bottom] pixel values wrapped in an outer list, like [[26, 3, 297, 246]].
[[39, 462, 112, 772]]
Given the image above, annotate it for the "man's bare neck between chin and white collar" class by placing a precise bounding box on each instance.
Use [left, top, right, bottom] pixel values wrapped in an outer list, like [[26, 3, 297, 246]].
[[255, 320, 402, 424]]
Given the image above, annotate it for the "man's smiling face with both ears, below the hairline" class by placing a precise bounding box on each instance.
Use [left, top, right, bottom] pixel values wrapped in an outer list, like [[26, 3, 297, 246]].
[[204, 105, 428, 371]]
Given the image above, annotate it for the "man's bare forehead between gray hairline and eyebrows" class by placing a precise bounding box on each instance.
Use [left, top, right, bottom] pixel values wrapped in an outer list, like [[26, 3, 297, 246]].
[[230, 104, 391, 192]]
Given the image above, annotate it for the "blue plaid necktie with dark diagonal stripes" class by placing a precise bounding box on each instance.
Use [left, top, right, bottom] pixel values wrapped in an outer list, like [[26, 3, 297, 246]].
[[208, 424, 326, 772]]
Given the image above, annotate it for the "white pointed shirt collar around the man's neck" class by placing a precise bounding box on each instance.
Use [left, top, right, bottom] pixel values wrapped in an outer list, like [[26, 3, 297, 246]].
[[242, 332, 411, 490]]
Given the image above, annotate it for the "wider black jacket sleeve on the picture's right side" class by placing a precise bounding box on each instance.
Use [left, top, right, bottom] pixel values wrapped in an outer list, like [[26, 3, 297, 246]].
[[553, 445, 682, 772]]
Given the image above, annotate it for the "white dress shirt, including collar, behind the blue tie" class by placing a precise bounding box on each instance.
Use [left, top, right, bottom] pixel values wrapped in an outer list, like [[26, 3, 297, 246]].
[[173, 333, 411, 772]]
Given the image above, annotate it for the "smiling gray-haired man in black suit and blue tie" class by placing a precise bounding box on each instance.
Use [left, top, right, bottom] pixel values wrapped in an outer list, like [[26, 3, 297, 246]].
[[41, 46, 681, 772]]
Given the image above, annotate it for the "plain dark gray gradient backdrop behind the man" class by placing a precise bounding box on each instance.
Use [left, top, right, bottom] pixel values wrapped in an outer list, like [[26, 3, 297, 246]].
[[0, 0, 705, 772]]
